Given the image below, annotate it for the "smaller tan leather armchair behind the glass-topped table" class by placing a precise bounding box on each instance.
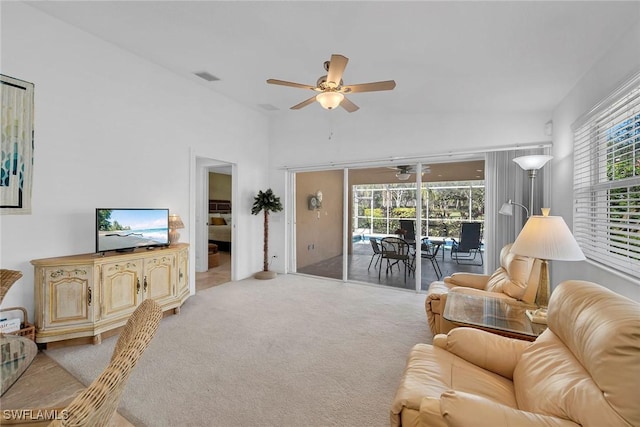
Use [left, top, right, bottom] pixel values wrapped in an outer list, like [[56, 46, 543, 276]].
[[425, 243, 541, 335]]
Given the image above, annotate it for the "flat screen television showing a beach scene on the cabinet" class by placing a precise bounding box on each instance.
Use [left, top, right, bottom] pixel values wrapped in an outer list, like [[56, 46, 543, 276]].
[[96, 208, 169, 252]]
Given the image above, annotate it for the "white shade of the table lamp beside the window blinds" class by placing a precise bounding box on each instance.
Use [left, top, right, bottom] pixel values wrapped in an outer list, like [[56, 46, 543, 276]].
[[511, 215, 585, 261]]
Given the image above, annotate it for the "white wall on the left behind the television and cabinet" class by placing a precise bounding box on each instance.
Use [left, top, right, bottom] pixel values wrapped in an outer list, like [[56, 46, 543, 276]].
[[0, 2, 268, 316]]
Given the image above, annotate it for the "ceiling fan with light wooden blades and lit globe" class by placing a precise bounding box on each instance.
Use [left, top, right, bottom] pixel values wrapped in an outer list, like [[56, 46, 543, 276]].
[[267, 54, 396, 113]]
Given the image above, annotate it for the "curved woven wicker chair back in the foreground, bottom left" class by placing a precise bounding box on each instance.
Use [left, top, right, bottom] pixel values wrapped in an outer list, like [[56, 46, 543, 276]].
[[10, 299, 162, 427]]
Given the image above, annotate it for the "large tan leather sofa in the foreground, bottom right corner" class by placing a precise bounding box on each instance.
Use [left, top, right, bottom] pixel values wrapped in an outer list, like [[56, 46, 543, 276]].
[[391, 280, 640, 427]]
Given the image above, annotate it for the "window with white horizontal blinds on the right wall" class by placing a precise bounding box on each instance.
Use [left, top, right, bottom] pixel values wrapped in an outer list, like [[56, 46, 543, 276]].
[[573, 75, 640, 278]]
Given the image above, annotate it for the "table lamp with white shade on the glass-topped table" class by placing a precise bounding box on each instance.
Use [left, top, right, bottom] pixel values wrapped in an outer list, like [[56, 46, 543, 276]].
[[511, 208, 586, 322]]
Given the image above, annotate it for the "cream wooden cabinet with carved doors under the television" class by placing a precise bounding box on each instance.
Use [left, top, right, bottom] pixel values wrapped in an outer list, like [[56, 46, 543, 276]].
[[31, 243, 189, 344]]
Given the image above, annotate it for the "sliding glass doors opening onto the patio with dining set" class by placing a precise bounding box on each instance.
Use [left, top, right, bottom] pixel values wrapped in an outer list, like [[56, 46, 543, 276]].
[[294, 161, 484, 290]]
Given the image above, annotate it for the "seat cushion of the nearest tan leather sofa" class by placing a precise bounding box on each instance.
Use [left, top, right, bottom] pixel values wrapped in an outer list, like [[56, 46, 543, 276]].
[[391, 344, 517, 425]]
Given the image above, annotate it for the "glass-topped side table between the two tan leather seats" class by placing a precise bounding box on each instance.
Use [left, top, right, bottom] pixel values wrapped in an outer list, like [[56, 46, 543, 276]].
[[443, 290, 547, 341]]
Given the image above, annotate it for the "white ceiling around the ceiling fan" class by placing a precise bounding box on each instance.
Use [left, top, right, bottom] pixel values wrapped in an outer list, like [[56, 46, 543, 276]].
[[29, 1, 640, 114]]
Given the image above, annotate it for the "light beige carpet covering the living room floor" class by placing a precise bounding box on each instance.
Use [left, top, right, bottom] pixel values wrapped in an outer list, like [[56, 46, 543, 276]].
[[46, 275, 432, 426]]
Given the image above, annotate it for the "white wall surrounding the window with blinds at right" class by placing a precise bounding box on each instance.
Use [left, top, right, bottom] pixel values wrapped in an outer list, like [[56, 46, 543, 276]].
[[551, 23, 640, 301]]
